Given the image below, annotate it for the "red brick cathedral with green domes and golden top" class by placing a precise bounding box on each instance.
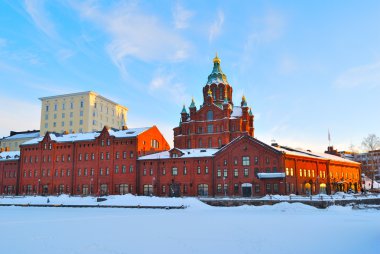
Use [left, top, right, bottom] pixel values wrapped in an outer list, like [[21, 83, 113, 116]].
[[174, 53, 254, 149]]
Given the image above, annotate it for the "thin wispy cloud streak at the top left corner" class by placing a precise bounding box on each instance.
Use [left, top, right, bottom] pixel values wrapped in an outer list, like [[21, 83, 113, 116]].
[[24, 0, 57, 38]]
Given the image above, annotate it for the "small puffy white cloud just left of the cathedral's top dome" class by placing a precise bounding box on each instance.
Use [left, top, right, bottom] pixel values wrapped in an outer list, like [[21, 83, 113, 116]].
[[149, 69, 191, 105]]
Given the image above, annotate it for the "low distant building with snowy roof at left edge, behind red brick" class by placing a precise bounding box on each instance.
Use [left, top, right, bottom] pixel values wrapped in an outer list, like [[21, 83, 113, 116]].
[[0, 130, 40, 152]]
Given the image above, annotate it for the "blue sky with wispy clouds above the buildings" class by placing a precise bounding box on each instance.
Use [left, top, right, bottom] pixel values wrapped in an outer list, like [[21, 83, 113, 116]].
[[0, 0, 380, 151]]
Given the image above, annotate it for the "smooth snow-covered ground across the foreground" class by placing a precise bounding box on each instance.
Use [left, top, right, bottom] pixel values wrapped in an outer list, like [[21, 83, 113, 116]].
[[0, 195, 380, 254]]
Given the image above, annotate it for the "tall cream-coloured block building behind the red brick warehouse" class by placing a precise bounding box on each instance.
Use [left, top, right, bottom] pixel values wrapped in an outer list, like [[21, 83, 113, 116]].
[[40, 91, 128, 136]]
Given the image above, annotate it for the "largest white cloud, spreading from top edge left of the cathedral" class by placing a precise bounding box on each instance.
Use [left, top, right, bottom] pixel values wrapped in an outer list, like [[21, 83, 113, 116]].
[[72, 2, 191, 77]]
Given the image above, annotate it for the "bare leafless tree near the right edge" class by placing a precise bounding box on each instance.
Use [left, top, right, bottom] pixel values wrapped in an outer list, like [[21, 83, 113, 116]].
[[362, 134, 380, 189]]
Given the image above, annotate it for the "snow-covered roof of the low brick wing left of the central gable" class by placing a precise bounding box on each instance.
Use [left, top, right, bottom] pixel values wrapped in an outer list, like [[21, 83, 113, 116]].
[[139, 148, 219, 160]]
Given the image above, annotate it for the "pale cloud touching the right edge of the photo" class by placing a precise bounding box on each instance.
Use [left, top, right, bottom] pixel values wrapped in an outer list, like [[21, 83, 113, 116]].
[[334, 62, 380, 88]]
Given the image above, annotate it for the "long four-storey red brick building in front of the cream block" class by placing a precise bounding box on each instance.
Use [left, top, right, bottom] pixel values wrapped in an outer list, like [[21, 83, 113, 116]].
[[19, 126, 169, 195]]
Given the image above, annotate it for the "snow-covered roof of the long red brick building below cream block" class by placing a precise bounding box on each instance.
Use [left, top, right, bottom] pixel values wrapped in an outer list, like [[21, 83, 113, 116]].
[[22, 127, 151, 145]]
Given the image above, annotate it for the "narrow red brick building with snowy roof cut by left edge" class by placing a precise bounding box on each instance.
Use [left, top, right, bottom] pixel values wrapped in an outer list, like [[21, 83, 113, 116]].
[[0, 151, 20, 195]]
